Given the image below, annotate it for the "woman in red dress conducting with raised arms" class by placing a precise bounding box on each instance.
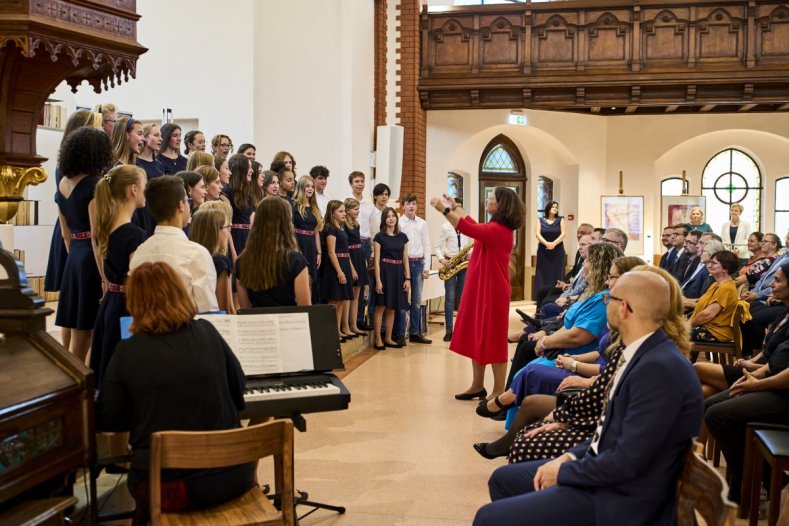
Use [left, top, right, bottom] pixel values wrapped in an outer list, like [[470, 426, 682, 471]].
[[431, 187, 526, 400]]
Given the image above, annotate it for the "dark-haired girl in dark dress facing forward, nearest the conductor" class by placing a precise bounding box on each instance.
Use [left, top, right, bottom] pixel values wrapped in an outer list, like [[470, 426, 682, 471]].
[[373, 206, 411, 351]]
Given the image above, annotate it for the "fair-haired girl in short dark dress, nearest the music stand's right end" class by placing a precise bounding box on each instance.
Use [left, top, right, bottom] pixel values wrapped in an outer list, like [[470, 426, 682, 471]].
[[321, 199, 358, 342]]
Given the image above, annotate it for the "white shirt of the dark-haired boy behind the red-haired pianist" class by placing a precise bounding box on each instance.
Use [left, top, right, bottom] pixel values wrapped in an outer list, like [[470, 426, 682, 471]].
[[129, 225, 219, 312]]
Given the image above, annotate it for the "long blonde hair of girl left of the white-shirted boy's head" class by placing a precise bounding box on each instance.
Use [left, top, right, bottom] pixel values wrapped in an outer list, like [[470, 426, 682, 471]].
[[96, 164, 145, 259]]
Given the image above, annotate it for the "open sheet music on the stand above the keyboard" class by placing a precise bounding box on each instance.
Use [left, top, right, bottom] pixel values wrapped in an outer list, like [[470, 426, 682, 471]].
[[196, 312, 315, 376]]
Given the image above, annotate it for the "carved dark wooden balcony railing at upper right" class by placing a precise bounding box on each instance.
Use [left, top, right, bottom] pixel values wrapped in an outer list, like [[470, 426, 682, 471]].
[[419, 0, 789, 114]]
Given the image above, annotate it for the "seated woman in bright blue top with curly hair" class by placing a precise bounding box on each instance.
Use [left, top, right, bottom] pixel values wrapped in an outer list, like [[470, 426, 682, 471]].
[[478, 243, 622, 417]]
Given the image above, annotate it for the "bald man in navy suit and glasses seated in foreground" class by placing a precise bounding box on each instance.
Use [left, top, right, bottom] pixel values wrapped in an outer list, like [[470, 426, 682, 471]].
[[474, 272, 703, 526]]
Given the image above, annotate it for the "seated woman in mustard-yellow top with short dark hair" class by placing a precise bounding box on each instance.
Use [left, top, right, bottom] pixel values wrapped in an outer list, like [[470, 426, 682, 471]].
[[690, 250, 740, 342]]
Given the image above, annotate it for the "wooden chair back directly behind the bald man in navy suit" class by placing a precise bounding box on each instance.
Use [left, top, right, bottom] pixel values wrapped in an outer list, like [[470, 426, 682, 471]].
[[677, 441, 737, 526]]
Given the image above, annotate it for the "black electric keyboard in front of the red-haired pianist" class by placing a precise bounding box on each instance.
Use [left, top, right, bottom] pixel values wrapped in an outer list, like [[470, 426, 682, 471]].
[[240, 374, 351, 418]]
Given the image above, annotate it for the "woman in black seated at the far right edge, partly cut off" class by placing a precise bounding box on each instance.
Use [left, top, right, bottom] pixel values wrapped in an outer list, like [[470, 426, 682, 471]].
[[697, 262, 789, 501]]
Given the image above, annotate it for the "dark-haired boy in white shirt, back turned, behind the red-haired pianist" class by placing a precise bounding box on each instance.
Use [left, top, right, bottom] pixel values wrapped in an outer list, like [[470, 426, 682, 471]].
[[129, 175, 219, 312]]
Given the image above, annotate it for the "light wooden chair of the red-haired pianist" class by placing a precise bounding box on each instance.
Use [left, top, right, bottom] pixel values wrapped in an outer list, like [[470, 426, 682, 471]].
[[149, 420, 295, 526]]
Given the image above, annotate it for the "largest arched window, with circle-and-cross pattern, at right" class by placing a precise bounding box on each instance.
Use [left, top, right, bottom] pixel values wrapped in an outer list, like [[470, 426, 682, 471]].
[[701, 148, 762, 232]]
